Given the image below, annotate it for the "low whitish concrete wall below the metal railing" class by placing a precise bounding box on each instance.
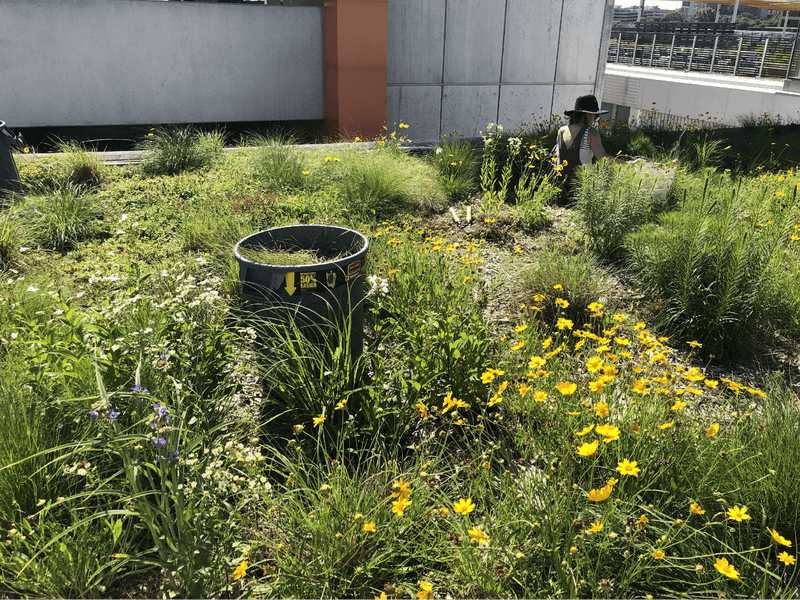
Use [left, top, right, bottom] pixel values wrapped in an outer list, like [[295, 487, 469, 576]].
[[602, 65, 800, 125]]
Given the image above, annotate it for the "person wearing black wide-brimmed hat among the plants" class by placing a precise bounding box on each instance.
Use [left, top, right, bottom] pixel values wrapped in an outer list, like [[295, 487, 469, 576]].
[[555, 94, 627, 190]]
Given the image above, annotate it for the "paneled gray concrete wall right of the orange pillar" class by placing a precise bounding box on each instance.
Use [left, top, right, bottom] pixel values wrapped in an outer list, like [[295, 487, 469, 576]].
[[386, 0, 614, 140]]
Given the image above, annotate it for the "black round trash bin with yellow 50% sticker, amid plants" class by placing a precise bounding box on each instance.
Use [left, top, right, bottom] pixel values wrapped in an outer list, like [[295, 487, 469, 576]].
[[233, 225, 369, 360]]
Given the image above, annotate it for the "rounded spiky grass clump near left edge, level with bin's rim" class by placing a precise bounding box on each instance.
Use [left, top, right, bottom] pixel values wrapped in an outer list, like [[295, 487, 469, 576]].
[[19, 183, 103, 252]]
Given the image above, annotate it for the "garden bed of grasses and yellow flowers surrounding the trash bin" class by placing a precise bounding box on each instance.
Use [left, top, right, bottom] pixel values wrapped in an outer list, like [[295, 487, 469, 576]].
[[0, 123, 800, 599]]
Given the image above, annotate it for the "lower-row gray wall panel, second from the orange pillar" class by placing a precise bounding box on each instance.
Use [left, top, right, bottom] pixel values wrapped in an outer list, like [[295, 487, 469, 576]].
[[442, 85, 500, 137]]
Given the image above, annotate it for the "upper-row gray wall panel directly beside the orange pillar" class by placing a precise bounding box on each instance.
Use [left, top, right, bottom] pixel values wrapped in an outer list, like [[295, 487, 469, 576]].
[[387, 0, 445, 85]]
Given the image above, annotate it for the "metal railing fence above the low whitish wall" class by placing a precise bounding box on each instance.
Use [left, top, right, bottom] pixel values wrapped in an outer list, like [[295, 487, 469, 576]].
[[607, 29, 797, 79]]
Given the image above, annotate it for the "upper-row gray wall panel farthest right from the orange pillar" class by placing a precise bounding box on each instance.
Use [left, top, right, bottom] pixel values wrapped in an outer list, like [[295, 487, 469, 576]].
[[555, 0, 606, 86]]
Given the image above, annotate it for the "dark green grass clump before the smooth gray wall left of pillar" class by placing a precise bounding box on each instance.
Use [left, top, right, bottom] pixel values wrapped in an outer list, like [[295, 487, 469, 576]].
[[138, 127, 225, 175]]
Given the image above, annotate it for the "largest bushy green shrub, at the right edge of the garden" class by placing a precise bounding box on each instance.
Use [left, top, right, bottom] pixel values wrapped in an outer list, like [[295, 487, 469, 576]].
[[627, 176, 791, 355]]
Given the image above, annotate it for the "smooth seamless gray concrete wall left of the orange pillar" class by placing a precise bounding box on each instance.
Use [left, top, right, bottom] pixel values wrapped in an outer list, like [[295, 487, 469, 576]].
[[0, 0, 325, 127]]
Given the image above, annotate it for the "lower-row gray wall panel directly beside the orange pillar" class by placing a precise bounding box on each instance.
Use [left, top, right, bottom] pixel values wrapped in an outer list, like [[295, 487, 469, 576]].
[[386, 85, 442, 142]]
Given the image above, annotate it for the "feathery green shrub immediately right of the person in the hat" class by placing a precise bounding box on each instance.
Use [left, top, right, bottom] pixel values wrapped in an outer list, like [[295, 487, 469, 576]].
[[574, 161, 666, 259]]
